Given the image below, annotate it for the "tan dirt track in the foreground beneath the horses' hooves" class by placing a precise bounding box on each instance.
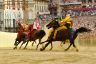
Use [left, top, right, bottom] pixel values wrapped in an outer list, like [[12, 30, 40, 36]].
[[0, 47, 96, 64]]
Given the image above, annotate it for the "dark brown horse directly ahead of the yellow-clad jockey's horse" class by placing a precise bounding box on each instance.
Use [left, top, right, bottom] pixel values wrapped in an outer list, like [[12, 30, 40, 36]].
[[24, 29, 46, 50]]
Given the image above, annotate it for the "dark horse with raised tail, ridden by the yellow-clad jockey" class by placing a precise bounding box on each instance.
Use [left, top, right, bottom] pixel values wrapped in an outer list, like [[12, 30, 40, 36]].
[[40, 21, 91, 51]]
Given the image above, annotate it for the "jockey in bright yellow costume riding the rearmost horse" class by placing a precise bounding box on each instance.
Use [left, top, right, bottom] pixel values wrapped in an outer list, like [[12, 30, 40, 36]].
[[53, 14, 73, 39]]
